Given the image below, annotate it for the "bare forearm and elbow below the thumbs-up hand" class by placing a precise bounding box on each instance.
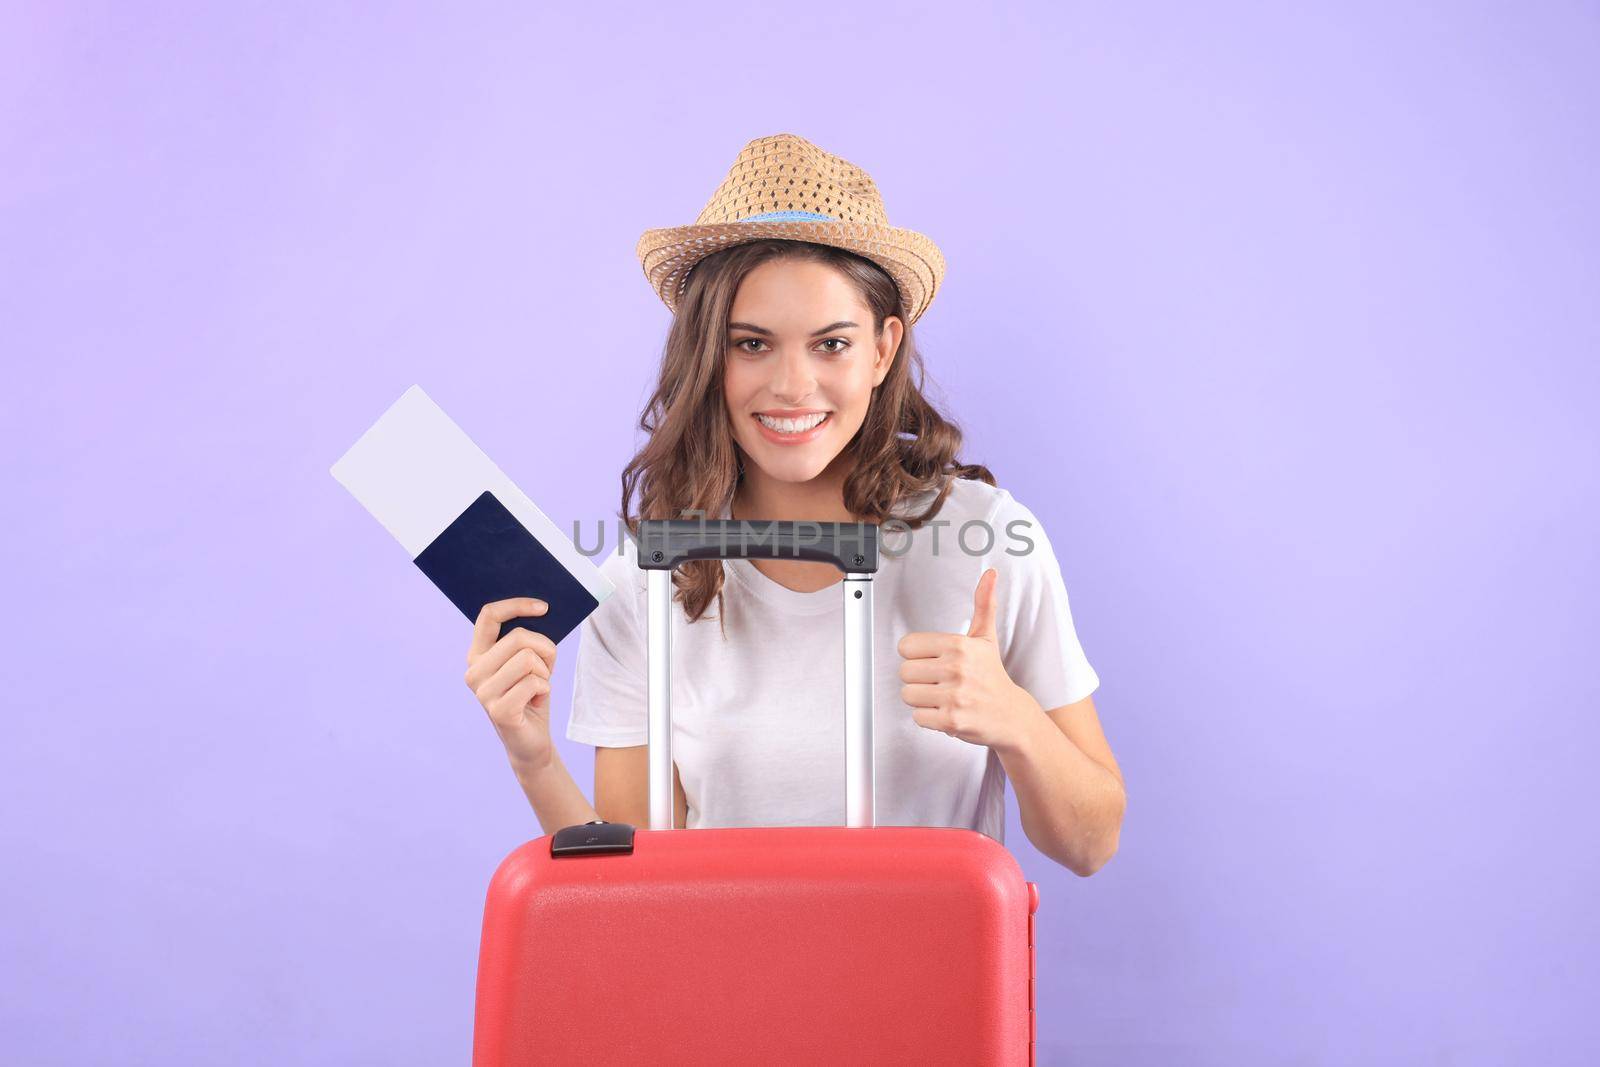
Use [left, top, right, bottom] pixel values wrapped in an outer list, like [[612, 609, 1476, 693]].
[[990, 689, 1128, 878]]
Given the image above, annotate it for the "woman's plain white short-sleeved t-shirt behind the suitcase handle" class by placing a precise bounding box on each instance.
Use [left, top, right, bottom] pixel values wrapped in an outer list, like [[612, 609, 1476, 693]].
[[566, 478, 1099, 843]]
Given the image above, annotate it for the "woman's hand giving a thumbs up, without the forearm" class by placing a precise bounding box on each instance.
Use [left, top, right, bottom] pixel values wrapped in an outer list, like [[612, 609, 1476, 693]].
[[898, 568, 1038, 747]]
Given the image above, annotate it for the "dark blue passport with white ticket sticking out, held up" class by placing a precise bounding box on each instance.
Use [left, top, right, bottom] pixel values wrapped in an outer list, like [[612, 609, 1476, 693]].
[[331, 386, 613, 643]]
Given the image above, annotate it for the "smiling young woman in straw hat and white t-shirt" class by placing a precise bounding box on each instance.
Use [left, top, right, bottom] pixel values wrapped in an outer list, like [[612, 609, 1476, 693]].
[[466, 134, 1125, 875]]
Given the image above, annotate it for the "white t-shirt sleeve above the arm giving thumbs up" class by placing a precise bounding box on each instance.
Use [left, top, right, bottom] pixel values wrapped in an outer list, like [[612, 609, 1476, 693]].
[[984, 490, 1099, 710]]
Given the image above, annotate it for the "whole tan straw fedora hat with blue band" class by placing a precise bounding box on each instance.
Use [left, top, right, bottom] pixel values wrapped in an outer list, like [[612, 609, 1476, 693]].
[[637, 133, 944, 325]]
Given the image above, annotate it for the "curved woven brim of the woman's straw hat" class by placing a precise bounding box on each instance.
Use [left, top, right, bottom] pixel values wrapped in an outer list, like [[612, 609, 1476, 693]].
[[637, 219, 944, 325]]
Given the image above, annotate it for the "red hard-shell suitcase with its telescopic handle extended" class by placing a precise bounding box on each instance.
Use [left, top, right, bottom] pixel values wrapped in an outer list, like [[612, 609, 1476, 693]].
[[474, 520, 1038, 1067]]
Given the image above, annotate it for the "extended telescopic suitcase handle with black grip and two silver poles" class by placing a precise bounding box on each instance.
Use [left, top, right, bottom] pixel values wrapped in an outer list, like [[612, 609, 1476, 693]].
[[635, 518, 878, 830]]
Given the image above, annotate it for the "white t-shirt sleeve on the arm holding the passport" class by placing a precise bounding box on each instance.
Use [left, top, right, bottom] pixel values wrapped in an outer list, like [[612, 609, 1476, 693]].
[[566, 537, 650, 749]]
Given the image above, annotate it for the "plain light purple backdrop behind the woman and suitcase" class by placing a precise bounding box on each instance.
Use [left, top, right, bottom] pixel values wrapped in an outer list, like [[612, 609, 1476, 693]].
[[0, 3, 1600, 1064]]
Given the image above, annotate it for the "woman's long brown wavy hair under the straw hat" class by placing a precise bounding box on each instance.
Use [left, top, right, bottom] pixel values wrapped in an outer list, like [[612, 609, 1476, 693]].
[[621, 240, 995, 622]]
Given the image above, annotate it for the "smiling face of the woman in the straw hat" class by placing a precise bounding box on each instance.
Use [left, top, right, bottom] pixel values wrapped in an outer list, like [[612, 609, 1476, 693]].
[[723, 259, 902, 482]]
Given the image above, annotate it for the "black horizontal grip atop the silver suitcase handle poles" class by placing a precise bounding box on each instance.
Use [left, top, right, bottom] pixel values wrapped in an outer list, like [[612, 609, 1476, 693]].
[[637, 518, 878, 574]]
